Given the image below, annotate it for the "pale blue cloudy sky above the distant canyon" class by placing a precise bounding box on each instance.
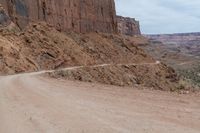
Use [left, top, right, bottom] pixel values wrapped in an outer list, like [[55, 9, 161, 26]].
[[115, 0, 200, 34]]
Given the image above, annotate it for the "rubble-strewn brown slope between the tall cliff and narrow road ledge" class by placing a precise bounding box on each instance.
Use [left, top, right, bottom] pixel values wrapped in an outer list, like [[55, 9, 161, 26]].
[[0, 23, 154, 74]]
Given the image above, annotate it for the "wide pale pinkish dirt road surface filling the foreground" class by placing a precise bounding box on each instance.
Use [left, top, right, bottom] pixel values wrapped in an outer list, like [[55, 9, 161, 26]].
[[0, 74, 200, 133]]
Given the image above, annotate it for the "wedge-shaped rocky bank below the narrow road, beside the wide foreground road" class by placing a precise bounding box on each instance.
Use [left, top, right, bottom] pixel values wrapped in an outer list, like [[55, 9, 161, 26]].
[[49, 63, 178, 91]]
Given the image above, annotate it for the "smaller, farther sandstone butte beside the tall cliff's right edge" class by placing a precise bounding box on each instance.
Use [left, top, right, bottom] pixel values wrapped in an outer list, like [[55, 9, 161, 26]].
[[117, 16, 141, 36]]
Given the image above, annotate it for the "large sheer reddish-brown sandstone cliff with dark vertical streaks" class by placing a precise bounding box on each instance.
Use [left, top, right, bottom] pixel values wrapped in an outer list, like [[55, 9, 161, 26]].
[[0, 0, 117, 33]]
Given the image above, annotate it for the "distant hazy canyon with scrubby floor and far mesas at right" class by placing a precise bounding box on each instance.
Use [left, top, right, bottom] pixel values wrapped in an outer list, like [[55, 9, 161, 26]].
[[145, 33, 200, 86]]
